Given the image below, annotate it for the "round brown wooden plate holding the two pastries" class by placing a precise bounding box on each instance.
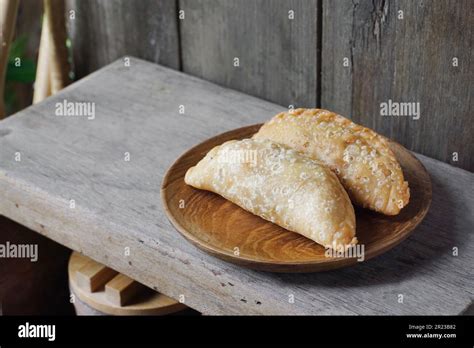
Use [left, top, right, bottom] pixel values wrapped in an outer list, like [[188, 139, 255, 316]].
[[161, 124, 431, 272]]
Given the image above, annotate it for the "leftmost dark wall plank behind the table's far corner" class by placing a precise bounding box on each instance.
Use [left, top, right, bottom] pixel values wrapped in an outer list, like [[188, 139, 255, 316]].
[[67, 0, 180, 78]]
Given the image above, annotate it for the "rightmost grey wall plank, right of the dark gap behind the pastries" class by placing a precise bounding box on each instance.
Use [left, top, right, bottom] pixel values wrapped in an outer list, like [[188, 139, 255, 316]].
[[321, 0, 474, 171]]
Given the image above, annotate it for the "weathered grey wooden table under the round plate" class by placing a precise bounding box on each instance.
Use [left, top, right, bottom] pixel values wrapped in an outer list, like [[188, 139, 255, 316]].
[[0, 59, 474, 314]]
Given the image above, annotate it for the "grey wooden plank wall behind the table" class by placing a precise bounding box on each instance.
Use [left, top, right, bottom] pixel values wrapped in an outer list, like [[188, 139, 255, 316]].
[[68, 0, 474, 171]]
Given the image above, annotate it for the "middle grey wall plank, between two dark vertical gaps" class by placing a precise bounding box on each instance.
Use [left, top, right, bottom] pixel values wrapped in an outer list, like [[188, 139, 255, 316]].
[[179, 0, 319, 107]]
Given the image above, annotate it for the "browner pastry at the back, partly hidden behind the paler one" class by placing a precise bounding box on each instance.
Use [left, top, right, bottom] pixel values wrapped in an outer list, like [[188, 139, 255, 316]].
[[254, 109, 410, 215]]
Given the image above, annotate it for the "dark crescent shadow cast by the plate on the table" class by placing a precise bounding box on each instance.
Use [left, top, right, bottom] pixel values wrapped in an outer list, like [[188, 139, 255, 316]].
[[278, 177, 462, 287]]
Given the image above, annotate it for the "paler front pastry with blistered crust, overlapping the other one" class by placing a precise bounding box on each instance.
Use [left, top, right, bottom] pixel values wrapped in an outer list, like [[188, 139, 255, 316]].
[[185, 139, 357, 248]]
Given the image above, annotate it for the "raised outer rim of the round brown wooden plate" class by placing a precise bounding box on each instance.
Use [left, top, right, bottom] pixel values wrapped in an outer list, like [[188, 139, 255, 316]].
[[160, 123, 433, 273]]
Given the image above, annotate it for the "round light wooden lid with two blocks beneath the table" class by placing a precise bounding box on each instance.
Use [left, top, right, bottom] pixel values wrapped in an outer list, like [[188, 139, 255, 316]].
[[68, 252, 187, 315]]
